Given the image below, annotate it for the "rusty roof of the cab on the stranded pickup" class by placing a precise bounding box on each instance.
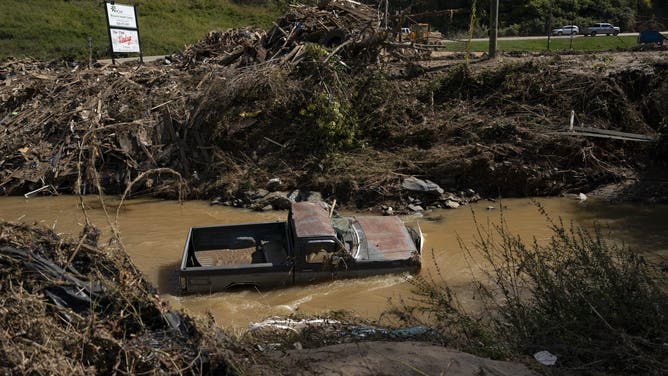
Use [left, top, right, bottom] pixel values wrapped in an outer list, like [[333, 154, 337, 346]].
[[292, 202, 336, 238]]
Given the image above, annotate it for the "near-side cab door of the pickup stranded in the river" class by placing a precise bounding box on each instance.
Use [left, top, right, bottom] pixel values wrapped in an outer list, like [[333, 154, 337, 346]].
[[295, 239, 337, 283]]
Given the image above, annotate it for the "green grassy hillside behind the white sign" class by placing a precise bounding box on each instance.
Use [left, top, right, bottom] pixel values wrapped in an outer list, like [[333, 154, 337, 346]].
[[0, 0, 278, 59]]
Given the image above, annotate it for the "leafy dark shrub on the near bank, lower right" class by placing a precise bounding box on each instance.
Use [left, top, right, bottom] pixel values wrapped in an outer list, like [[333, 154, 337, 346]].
[[393, 205, 668, 375]]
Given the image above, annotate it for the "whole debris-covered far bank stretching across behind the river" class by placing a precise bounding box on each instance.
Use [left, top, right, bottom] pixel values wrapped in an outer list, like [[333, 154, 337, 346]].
[[0, 1, 668, 212]]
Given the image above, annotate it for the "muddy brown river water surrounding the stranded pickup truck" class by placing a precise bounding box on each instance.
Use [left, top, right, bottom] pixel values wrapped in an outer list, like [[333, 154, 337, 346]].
[[0, 196, 668, 328]]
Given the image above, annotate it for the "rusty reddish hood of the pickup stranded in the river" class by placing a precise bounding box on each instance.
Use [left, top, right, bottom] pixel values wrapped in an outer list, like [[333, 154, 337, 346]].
[[355, 217, 417, 261]]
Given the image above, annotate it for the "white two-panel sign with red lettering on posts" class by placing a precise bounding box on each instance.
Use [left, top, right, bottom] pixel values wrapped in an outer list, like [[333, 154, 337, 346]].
[[104, 1, 144, 64]]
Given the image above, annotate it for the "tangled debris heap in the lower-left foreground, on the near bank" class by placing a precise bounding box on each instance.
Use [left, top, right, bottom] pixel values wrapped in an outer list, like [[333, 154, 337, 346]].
[[0, 222, 228, 375]]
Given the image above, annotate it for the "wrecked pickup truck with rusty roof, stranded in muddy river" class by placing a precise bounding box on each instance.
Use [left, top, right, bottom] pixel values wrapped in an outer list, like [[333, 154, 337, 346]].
[[179, 202, 423, 294]]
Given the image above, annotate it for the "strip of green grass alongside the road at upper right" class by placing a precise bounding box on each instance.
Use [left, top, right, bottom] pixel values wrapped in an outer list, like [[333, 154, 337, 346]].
[[445, 36, 637, 52]]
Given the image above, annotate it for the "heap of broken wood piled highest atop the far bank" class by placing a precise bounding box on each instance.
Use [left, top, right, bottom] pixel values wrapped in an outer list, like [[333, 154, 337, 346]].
[[172, 0, 387, 68]]
